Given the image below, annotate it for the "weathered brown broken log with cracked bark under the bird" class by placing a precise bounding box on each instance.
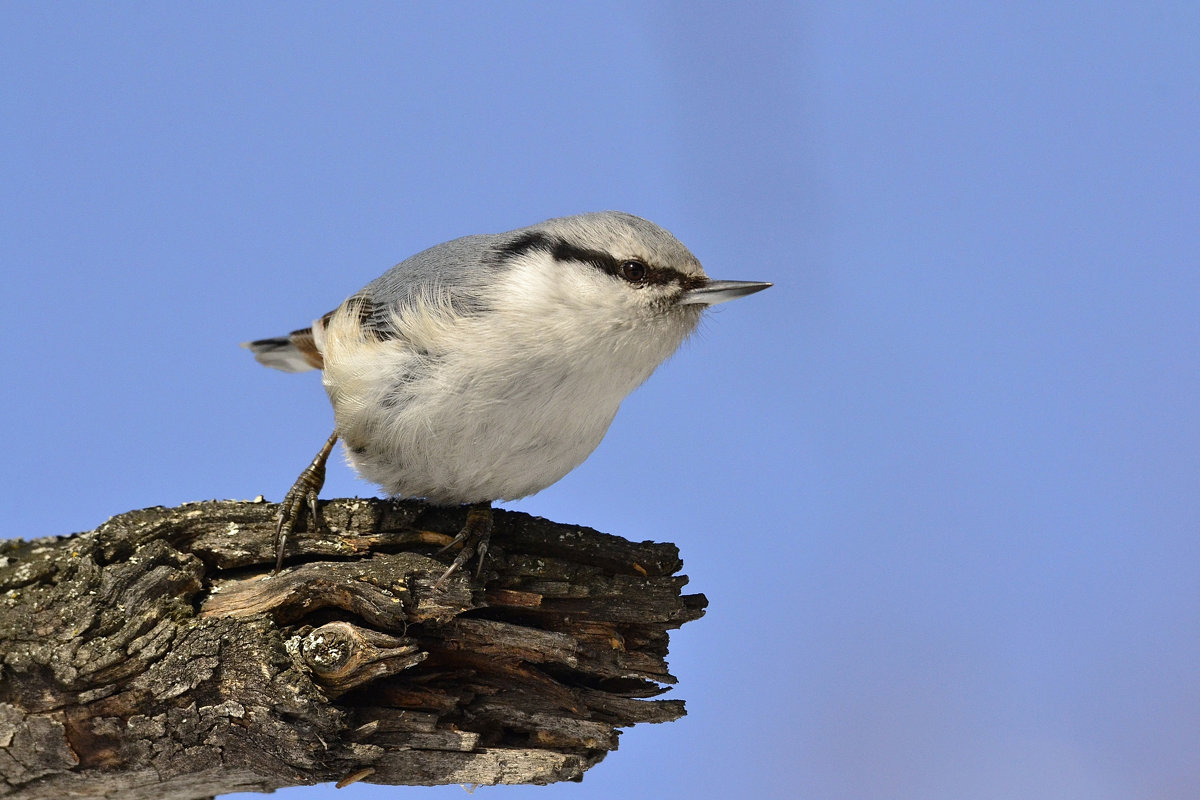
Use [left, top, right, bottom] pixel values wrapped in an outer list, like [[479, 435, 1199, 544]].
[[0, 499, 706, 800]]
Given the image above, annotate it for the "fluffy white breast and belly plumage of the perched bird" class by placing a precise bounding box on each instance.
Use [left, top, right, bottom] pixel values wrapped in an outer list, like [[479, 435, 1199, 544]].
[[322, 253, 698, 504]]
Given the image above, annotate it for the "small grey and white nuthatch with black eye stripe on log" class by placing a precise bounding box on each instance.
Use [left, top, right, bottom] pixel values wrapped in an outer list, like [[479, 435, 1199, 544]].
[[242, 211, 772, 587]]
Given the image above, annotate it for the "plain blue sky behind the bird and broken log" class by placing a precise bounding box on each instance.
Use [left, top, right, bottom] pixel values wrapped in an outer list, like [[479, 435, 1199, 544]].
[[0, 2, 1200, 800]]
